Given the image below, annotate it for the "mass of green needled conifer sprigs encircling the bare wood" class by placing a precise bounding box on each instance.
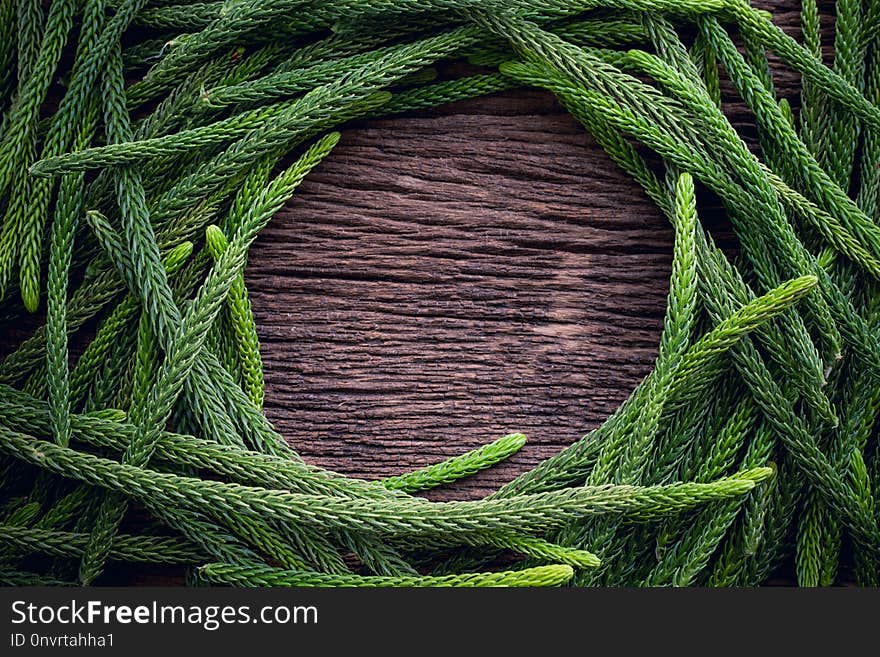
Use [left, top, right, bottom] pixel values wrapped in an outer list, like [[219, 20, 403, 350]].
[[0, 0, 880, 586]]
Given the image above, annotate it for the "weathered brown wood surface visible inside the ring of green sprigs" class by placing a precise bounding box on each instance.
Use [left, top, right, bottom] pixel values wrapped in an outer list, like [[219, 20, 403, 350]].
[[247, 90, 672, 498]]
